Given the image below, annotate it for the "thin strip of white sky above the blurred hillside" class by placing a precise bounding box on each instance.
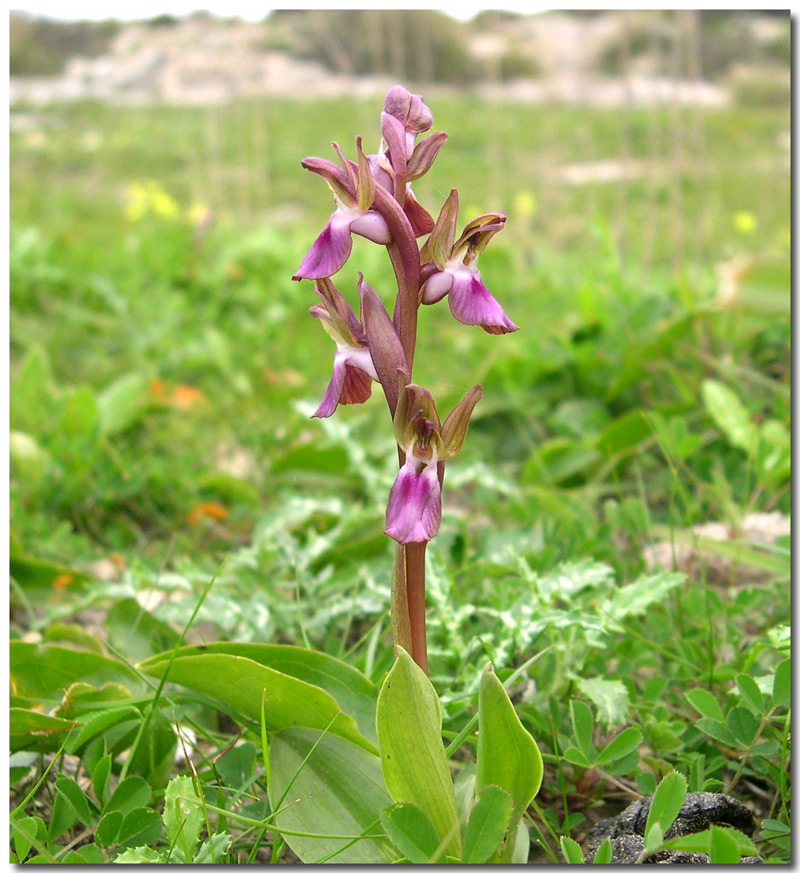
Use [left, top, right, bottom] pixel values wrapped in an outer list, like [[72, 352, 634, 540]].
[[14, 0, 541, 21]]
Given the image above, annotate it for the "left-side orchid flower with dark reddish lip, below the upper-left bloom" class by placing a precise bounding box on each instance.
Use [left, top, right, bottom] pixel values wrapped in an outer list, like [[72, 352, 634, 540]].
[[309, 279, 378, 418]]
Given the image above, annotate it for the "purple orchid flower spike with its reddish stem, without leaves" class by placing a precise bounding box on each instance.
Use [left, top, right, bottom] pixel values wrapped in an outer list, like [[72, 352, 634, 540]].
[[293, 85, 517, 671]]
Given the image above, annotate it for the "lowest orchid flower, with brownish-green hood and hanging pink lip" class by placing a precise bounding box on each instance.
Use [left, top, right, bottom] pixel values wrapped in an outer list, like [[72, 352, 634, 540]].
[[384, 380, 482, 544]]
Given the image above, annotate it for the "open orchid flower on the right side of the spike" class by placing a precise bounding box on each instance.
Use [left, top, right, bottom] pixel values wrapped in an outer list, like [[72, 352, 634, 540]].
[[422, 189, 519, 334]]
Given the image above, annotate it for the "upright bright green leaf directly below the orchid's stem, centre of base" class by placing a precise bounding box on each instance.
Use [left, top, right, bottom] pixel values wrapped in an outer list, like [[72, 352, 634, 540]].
[[376, 647, 460, 857]]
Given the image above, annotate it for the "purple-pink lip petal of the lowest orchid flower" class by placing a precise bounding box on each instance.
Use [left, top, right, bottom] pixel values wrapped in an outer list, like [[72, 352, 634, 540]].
[[384, 456, 442, 544]]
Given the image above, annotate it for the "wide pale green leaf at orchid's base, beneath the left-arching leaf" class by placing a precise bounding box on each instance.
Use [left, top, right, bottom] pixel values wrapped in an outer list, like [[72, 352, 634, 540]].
[[269, 728, 397, 864]]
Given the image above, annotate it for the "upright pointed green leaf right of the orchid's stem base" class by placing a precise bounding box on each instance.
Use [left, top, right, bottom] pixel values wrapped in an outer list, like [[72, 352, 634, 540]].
[[475, 665, 544, 859]]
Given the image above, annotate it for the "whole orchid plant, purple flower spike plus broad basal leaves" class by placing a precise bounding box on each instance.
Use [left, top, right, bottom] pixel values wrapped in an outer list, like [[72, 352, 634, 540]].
[[134, 86, 543, 863]]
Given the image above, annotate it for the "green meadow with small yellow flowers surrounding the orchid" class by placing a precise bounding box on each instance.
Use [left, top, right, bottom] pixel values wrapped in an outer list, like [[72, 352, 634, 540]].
[[10, 92, 791, 862]]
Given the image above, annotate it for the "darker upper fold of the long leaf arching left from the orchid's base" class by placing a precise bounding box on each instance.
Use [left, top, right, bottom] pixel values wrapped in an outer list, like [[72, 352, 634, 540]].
[[148, 643, 378, 745]]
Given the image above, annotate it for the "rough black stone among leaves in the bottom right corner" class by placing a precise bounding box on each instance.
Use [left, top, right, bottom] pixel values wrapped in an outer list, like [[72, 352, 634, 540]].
[[586, 791, 761, 864]]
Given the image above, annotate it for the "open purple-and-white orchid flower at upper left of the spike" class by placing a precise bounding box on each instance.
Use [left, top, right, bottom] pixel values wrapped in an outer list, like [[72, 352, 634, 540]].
[[292, 139, 392, 280]]
